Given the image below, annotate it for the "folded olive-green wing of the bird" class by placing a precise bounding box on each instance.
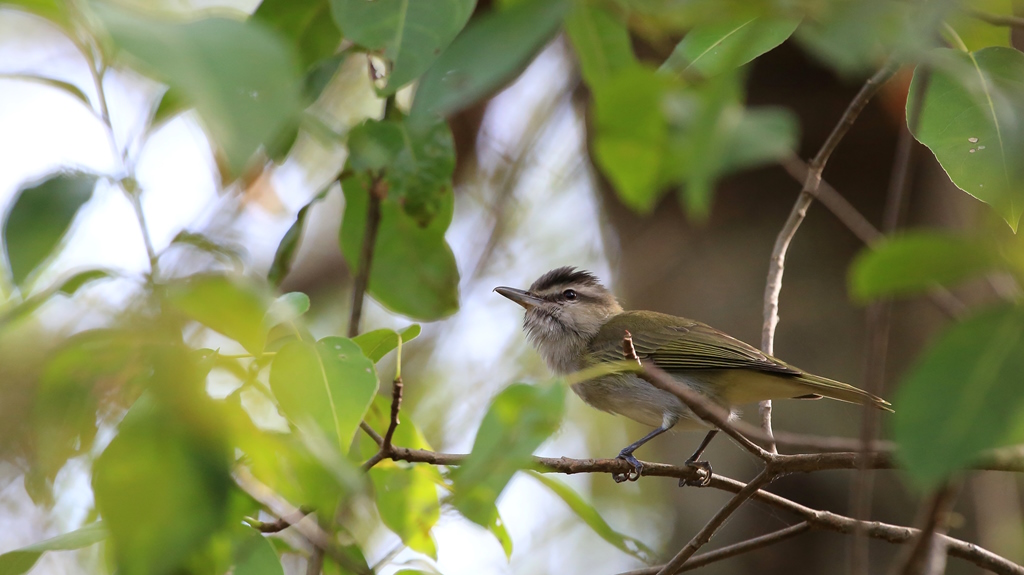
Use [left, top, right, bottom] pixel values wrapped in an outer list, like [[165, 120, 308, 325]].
[[589, 311, 803, 375]]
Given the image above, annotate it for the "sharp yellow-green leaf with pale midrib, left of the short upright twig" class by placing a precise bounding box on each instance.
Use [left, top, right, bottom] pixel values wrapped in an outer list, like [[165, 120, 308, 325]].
[[270, 337, 378, 453]]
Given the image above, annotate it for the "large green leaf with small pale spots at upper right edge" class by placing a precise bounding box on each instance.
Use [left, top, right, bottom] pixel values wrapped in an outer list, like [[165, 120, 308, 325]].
[[907, 47, 1024, 231]]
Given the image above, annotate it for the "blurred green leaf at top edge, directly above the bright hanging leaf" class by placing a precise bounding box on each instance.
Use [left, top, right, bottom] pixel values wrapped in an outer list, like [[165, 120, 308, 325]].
[[565, 2, 637, 89]]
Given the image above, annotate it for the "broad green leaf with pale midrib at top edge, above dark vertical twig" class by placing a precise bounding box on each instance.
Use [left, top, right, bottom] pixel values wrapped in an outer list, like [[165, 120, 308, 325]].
[[331, 0, 476, 95]]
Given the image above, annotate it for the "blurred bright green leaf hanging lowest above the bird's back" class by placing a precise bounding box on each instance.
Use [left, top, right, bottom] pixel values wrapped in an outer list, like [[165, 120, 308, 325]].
[[593, 67, 670, 214]]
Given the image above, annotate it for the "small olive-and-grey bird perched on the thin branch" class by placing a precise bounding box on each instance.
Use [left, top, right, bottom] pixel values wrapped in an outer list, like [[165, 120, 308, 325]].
[[495, 266, 892, 486]]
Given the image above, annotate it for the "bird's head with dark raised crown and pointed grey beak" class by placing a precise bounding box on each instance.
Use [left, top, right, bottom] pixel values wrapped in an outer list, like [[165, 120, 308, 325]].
[[495, 267, 623, 372]]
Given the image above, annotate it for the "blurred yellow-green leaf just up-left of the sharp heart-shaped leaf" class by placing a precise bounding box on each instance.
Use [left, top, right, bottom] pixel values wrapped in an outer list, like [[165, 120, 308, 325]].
[[165, 274, 267, 355]]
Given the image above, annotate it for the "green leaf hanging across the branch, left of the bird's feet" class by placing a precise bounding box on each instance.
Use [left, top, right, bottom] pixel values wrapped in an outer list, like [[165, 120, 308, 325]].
[[452, 382, 565, 526]]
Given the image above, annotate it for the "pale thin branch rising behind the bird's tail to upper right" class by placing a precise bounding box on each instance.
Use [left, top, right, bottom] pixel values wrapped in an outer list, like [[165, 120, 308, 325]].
[[759, 60, 898, 452]]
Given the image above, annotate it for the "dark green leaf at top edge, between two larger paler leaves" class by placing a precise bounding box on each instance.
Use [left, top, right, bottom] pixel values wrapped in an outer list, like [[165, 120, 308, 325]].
[[252, 0, 341, 70]]
